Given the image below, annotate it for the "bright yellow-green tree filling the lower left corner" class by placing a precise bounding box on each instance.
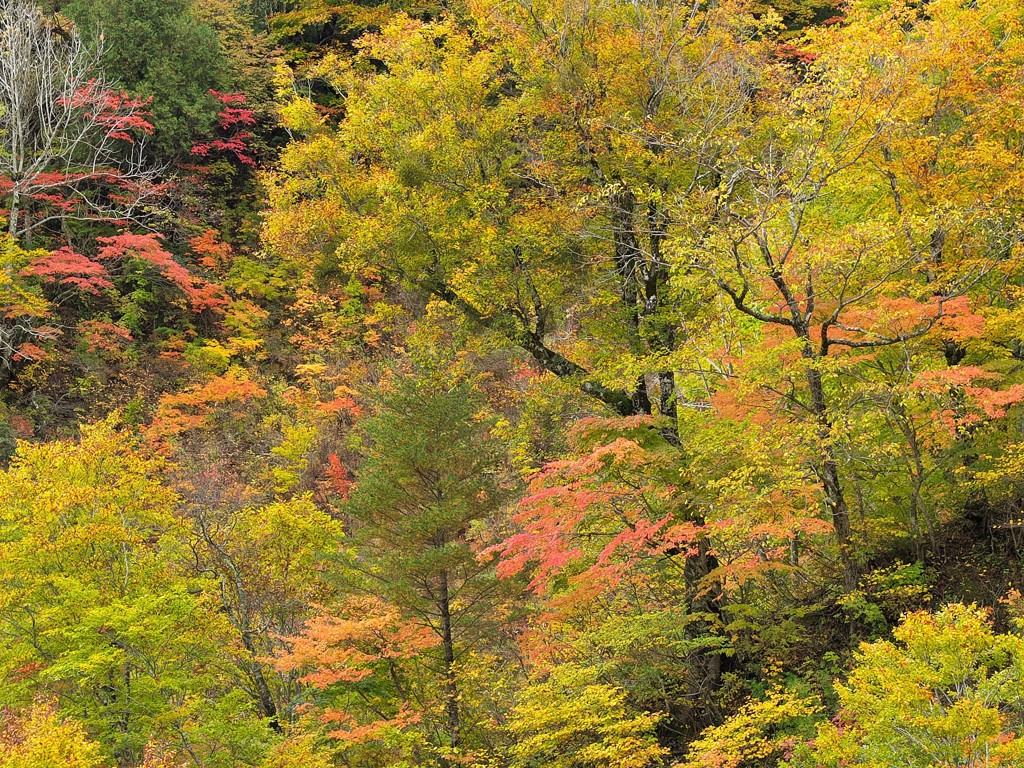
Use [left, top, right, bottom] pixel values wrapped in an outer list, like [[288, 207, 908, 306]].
[[0, 422, 270, 767]]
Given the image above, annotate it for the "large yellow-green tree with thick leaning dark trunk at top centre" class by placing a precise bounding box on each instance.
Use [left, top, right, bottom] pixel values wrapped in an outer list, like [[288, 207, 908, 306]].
[[266, 0, 760, 423]]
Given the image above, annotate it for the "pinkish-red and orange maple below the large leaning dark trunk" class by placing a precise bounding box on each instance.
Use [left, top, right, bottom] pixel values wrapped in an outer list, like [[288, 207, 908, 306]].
[[494, 417, 749, 730]]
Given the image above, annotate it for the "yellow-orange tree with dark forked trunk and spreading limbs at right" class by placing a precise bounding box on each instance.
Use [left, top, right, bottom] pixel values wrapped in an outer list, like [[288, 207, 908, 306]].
[[675, 2, 1024, 590]]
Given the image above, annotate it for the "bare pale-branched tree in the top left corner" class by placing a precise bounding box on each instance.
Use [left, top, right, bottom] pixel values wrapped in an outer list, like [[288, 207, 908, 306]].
[[0, 0, 159, 240]]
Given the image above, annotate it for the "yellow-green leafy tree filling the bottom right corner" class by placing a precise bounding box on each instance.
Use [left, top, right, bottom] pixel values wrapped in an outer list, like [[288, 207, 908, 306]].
[[792, 604, 1024, 768]]
